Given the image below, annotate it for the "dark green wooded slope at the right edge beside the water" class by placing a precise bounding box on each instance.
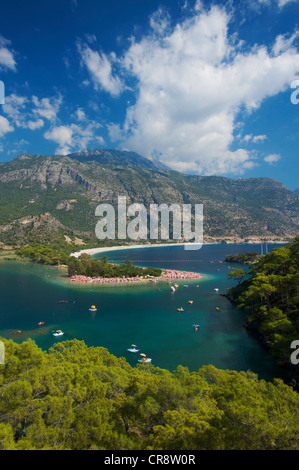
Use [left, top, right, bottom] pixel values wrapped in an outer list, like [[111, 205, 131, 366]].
[[229, 236, 299, 383]]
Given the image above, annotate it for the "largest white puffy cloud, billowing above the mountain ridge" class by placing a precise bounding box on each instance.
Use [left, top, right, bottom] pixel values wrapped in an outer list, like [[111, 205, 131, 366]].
[[89, 2, 299, 174]]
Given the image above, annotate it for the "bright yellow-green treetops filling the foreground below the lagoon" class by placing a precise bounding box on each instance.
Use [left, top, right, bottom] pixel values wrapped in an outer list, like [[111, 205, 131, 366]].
[[0, 340, 299, 450]]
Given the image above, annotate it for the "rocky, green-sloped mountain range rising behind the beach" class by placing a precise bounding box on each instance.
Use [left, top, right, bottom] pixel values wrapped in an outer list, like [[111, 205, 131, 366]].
[[0, 149, 299, 243]]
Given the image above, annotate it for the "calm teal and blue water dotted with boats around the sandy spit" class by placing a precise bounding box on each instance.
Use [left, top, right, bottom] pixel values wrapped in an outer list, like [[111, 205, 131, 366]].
[[0, 245, 288, 379]]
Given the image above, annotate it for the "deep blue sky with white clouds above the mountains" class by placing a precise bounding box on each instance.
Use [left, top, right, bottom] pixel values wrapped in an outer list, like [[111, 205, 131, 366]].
[[0, 0, 299, 190]]
